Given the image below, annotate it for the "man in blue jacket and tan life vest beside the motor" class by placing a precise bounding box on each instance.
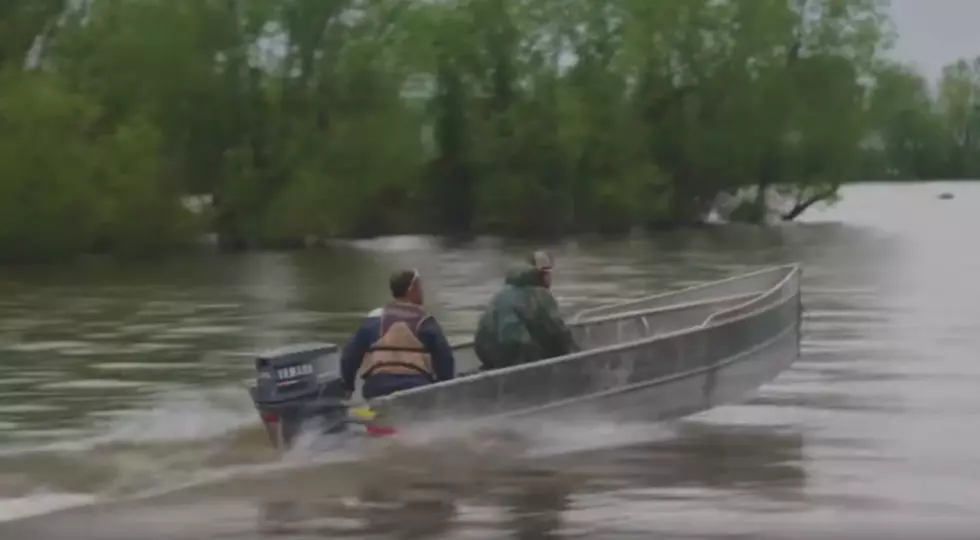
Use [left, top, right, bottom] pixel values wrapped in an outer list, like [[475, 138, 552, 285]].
[[340, 270, 456, 399]]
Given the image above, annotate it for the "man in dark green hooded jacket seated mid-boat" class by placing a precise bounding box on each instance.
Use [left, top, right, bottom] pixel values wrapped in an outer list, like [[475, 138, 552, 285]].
[[474, 251, 579, 370]]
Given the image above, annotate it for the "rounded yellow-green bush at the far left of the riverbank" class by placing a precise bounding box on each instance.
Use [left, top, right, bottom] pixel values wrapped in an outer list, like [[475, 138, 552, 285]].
[[0, 72, 189, 260]]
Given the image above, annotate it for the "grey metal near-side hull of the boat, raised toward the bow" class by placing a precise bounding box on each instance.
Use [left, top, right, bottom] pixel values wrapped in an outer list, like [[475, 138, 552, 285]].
[[371, 266, 801, 434]]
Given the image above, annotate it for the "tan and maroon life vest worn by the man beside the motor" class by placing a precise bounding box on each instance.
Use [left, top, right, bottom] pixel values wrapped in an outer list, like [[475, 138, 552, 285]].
[[359, 302, 433, 379]]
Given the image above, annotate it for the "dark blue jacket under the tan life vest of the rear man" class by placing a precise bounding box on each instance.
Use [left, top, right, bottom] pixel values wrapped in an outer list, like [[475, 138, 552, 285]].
[[340, 309, 456, 399]]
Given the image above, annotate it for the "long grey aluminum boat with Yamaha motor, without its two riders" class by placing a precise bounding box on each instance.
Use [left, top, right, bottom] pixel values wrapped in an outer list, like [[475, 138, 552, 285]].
[[249, 264, 802, 449]]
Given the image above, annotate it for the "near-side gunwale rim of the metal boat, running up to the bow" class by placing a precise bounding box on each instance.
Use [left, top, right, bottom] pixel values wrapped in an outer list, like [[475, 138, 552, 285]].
[[370, 263, 801, 404]]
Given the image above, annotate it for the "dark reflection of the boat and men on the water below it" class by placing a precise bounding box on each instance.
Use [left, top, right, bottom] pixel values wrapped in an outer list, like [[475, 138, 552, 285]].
[[247, 424, 806, 538]]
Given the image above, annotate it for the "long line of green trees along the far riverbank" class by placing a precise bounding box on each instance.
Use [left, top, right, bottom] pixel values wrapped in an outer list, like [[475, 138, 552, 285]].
[[0, 0, 980, 260]]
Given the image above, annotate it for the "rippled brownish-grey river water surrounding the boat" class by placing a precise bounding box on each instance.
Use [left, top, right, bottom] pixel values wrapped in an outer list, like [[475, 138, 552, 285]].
[[0, 183, 980, 540]]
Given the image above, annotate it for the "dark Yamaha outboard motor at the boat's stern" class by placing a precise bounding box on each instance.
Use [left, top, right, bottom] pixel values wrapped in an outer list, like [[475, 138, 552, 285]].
[[249, 343, 347, 450]]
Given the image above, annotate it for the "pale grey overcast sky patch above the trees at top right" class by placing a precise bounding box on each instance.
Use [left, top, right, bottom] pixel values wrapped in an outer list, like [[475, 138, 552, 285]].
[[892, 0, 980, 80]]
